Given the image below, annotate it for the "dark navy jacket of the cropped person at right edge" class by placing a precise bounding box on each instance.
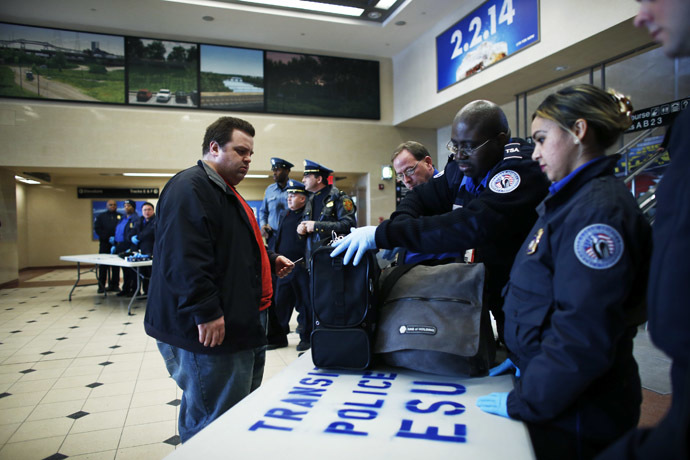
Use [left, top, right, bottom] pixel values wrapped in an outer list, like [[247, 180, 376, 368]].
[[602, 109, 690, 459]]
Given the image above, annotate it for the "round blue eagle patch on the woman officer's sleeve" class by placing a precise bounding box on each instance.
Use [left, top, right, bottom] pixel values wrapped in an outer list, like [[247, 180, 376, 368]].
[[573, 224, 623, 270]]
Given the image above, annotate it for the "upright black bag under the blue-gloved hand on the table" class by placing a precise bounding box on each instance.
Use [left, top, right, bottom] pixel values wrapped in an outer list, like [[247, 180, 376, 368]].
[[309, 246, 380, 370]]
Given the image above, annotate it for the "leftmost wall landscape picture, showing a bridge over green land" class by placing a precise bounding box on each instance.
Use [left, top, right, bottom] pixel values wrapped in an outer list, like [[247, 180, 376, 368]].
[[0, 23, 125, 103]]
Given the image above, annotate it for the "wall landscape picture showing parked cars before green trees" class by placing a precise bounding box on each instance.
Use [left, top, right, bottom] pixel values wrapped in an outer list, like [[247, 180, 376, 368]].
[[126, 37, 199, 107]]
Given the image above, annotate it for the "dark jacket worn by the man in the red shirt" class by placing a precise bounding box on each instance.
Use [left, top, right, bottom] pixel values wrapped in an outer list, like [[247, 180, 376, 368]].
[[144, 161, 275, 354]]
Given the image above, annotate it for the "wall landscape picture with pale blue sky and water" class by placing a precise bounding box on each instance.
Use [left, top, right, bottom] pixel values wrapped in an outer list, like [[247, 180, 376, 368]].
[[201, 45, 264, 112]]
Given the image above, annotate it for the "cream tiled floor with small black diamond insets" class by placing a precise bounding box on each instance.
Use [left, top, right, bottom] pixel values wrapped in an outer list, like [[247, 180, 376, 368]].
[[0, 269, 299, 460]]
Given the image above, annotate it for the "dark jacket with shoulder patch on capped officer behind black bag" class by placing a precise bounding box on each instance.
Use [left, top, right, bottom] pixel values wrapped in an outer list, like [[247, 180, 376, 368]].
[[302, 186, 357, 261]]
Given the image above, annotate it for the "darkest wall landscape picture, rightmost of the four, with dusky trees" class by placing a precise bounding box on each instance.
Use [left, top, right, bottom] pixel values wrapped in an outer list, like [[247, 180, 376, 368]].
[[264, 51, 380, 120]]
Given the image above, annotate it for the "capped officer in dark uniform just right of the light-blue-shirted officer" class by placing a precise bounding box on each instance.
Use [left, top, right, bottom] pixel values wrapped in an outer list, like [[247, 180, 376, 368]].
[[268, 179, 313, 351]]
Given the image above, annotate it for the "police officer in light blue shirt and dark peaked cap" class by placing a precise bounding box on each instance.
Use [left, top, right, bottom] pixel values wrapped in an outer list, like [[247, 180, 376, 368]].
[[259, 157, 294, 251]]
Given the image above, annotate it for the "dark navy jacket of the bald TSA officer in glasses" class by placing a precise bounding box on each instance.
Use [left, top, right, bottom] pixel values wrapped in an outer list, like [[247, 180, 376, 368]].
[[376, 139, 549, 308]]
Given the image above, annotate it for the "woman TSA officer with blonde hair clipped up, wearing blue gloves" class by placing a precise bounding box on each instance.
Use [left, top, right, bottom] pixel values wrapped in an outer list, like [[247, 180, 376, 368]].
[[477, 85, 651, 459]]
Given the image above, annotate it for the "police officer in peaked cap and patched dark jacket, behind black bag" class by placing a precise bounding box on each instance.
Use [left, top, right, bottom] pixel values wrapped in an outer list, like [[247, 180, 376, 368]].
[[297, 160, 357, 264]]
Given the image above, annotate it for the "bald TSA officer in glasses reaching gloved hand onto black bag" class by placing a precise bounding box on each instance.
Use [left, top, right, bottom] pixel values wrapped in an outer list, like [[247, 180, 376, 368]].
[[331, 100, 549, 341]]
